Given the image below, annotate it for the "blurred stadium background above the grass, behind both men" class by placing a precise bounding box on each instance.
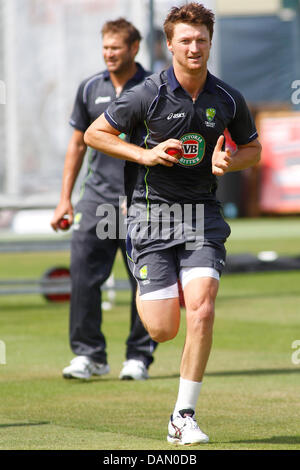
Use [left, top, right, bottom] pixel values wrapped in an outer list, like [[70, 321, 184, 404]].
[[0, 0, 300, 221]]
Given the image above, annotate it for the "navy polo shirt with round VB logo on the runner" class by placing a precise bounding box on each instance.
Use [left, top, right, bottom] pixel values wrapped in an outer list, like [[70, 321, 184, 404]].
[[105, 66, 258, 204]]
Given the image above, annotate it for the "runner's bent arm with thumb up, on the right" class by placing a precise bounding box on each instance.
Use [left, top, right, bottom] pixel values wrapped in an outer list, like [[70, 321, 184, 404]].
[[212, 135, 261, 176]]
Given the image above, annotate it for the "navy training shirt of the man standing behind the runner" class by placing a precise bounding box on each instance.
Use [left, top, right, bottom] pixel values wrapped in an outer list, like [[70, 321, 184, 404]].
[[70, 63, 150, 206]]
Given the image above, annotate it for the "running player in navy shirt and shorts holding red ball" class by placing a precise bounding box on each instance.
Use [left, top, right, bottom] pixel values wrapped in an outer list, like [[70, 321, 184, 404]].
[[85, 2, 261, 445]]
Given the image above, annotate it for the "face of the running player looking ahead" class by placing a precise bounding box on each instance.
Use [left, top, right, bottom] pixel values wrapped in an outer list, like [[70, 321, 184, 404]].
[[167, 23, 211, 73]]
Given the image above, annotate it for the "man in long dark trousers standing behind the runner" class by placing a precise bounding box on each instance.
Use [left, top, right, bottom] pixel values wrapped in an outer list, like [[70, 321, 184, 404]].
[[51, 18, 155, 380]]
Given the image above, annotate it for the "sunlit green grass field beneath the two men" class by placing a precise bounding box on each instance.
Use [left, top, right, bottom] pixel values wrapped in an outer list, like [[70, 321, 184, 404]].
[[0, 218, 300, 450]]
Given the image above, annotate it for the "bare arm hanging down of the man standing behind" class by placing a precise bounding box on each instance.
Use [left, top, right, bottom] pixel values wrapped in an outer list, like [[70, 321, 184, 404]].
[[51, 129, 86, 230]]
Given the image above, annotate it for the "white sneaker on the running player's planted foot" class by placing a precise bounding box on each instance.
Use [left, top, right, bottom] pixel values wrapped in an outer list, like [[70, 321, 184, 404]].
[[167, 410, 209, 445]]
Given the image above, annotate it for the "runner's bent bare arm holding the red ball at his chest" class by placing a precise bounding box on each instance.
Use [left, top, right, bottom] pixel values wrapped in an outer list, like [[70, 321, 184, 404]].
[[84, 114, 181, 166]]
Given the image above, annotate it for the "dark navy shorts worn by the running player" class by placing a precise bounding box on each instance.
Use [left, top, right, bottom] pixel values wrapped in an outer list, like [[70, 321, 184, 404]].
[[126, 201, 230, 295]]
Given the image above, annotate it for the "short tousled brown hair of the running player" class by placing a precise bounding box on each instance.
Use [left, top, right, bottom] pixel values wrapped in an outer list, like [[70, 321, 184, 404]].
[[164, 2, 215, 41]]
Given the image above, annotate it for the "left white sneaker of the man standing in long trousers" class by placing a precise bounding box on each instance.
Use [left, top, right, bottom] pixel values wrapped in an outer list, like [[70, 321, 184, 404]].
[[62, 356, 109, 379]]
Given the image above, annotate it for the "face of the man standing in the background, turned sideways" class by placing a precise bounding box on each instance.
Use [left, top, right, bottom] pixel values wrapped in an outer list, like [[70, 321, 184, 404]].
[[102, 33, 137, 74]]
